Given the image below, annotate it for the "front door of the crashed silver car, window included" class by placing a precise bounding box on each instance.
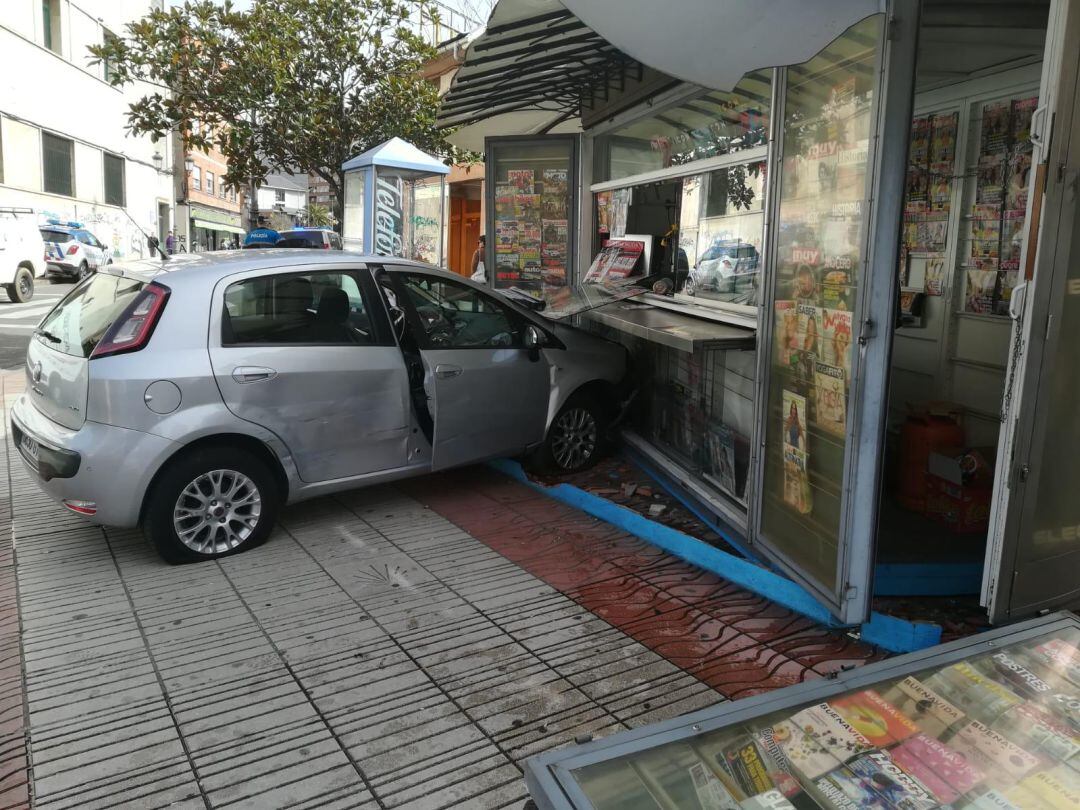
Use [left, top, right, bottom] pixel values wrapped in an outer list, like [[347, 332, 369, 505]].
[[388, 268, 551, 470]]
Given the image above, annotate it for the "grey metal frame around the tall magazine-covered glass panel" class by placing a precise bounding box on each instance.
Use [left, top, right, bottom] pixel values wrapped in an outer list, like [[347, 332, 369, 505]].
[[750, 0, 920, 624]]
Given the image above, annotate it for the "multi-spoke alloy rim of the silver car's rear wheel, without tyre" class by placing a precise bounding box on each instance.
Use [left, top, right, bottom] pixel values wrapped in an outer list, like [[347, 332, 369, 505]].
[[173, 470, 262, 554]]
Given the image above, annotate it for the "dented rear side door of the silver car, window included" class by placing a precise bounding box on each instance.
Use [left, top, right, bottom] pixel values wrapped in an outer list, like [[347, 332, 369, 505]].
[[210, 265, 411, 482]]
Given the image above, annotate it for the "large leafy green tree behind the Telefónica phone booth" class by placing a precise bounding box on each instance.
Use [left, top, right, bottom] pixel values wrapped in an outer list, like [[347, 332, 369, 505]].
[[90, 0, 454, 230]]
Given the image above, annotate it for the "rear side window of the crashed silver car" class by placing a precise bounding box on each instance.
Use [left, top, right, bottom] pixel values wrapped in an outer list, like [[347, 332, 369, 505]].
[[221, 270, 379, 346]]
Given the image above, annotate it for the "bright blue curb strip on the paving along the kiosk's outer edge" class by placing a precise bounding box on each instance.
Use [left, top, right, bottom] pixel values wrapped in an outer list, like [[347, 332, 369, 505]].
[[489, 459, 941, 652]]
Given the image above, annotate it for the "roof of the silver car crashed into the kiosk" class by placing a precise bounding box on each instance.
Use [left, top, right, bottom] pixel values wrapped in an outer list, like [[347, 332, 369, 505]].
[[107, 247, 444, 284]]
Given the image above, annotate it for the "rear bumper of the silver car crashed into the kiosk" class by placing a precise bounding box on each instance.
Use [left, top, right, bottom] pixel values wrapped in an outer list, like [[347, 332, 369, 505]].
[[11, 394, 178, 526]]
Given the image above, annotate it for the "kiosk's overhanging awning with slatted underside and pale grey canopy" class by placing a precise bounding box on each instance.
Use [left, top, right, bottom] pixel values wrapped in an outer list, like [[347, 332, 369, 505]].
[[438, 0, 883, 151]]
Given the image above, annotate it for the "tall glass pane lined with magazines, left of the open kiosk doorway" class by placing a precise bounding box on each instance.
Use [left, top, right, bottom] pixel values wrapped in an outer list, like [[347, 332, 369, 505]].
[[761, 15, 881, 592]]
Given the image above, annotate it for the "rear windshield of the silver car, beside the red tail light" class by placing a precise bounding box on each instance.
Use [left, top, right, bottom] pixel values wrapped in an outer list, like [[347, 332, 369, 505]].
[[35, 273, 145, 357]]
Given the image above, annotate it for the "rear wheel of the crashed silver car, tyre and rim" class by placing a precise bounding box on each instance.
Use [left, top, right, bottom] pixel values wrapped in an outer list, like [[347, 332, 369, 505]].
[[143, 447, 279, 563]]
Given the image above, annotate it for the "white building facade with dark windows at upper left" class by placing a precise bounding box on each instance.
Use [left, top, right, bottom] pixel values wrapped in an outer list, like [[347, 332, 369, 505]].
[[0, 0, 174, 259]]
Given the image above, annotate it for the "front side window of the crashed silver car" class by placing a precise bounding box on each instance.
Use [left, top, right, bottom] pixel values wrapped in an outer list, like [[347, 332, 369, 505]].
[[399, 273, 523, 349]]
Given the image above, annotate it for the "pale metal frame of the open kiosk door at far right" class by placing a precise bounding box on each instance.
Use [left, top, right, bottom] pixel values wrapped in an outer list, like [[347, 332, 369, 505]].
[[981, 0, 1080, 622]]
